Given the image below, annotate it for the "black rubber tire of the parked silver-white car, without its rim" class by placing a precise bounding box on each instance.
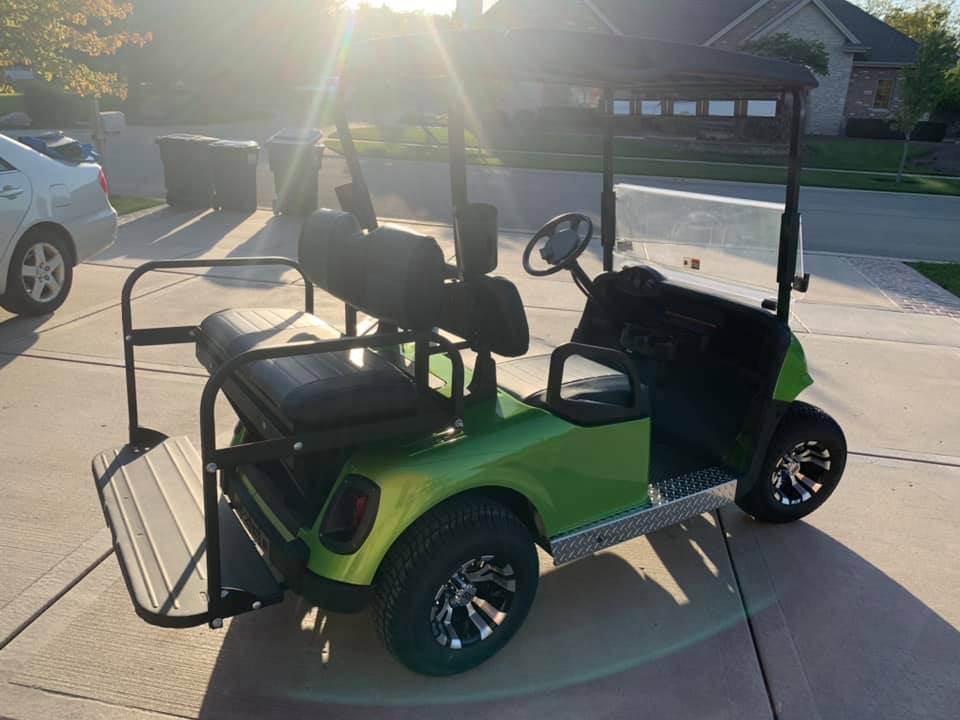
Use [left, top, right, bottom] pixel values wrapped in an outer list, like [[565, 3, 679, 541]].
[[0, 229, 73, 316]]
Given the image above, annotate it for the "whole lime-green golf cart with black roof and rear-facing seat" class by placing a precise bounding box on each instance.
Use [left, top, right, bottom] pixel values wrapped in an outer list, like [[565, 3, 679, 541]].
[[93, 31, 846, 675]]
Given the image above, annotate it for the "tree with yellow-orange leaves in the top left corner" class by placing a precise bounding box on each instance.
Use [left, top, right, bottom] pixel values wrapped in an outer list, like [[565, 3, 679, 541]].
[[0, 0, 150, 97]]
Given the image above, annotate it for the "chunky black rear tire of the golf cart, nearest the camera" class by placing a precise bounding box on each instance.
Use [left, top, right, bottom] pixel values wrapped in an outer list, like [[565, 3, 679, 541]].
[[374, 497, 539, 675]]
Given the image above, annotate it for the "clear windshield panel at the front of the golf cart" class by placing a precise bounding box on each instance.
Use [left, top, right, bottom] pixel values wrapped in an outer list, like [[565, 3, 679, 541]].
[[614, 184, 803, 296]]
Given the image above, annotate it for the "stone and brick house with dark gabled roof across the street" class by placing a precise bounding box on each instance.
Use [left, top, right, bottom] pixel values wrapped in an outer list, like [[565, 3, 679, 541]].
[[480, 0, 917, 135]]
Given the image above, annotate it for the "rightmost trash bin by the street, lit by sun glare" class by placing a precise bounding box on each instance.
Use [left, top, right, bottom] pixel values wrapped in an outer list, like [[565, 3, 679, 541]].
[[267, 129, 324, 215]]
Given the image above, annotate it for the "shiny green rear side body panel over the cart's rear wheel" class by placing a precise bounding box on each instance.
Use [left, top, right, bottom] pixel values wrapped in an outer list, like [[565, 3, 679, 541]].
[[300, 393, 650, 584]]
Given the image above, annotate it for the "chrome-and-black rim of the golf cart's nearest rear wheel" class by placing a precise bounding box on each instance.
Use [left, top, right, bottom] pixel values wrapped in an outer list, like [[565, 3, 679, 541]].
[[430, 555, 517, 650]]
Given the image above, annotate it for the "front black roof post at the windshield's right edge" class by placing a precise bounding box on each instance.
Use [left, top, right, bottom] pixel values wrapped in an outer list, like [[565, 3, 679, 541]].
[[777, 88, 806, 323]]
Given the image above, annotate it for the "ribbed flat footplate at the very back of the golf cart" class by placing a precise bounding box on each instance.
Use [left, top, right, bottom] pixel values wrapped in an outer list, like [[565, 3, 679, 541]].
[[93, 437, 283, 627]]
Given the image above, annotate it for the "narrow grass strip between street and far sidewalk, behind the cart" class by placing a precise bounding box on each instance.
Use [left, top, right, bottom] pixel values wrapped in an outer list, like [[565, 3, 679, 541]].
[[326, 135, 960, 195]]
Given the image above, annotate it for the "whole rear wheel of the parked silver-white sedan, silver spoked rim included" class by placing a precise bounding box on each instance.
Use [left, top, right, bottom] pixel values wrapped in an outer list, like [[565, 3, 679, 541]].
[[0, 230, 73, 315]]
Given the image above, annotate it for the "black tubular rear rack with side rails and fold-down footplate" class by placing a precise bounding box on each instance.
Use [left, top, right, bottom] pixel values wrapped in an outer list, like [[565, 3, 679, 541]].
[[93, 257, 464, 628]]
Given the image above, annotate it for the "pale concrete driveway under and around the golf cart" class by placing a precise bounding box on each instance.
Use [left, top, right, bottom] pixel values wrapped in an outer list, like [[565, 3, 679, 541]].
[[0, 210, 960, 720]]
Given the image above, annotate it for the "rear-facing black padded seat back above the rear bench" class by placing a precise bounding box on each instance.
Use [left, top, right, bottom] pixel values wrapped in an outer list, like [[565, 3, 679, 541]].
[[299, 210, 444, 330]]
